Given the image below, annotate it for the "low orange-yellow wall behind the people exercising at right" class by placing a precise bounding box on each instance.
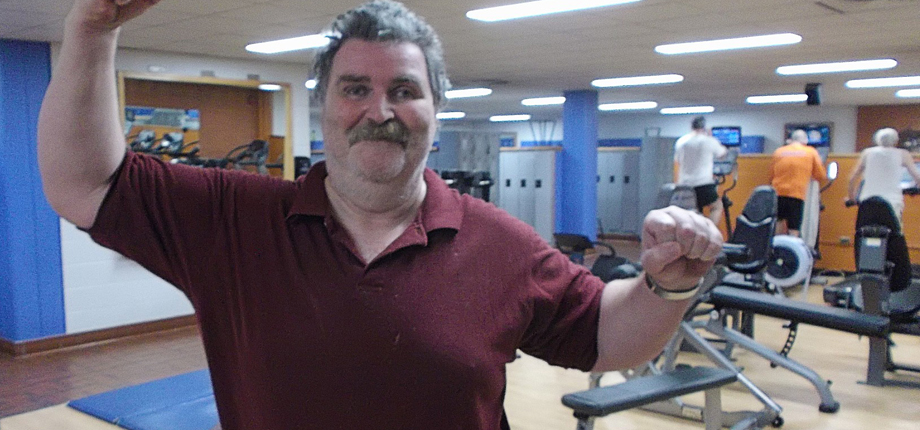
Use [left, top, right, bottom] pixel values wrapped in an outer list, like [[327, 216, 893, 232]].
[[719, 154, 920, 271]]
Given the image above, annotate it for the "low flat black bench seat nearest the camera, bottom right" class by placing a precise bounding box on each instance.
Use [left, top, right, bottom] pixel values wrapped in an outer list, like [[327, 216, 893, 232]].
[[562, 367, 737, 430]]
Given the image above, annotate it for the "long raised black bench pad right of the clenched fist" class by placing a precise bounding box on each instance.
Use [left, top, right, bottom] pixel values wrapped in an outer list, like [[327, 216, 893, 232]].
[[709, 286, 890, 337]]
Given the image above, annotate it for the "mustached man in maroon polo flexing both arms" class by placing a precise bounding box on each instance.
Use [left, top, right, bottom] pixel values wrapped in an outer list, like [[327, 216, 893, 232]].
[[39, 0, 721, 430]]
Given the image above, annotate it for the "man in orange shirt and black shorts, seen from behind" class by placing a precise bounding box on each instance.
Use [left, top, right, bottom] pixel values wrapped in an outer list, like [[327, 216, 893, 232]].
[[770, 130, 827, 237]]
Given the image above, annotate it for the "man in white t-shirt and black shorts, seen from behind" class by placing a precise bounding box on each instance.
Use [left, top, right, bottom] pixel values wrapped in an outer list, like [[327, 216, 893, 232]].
[[674, 116, 728, 224]]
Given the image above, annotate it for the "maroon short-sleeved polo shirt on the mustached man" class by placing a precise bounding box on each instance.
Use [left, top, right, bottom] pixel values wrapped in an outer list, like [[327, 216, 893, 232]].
[[88, 152, 603, 430]]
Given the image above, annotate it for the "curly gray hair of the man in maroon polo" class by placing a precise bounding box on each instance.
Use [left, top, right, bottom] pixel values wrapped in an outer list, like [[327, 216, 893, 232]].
[[313, 0, 450, 109]]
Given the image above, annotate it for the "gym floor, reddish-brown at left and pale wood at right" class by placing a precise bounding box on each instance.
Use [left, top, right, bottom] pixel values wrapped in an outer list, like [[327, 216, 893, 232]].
[[0, 250, 920, 430]]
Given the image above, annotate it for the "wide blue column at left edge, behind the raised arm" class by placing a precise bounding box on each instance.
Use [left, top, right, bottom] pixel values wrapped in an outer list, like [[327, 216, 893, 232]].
[[0, 39, 65, 341]]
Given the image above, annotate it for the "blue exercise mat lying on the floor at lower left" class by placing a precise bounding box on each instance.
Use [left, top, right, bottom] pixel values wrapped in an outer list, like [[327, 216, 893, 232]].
[[67, 369, 219, 430]]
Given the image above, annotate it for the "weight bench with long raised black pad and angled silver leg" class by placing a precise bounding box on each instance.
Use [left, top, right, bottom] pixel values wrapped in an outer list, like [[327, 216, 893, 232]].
[[693, 286, 890, 413]]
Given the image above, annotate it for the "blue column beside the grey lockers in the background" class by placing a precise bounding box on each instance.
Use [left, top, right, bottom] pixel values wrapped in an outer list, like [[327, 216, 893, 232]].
[[556, 90, 597, 240]]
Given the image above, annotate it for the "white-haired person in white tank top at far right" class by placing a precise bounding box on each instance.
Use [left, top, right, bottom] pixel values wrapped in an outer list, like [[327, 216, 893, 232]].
[[849, 128, 920, 221]]
